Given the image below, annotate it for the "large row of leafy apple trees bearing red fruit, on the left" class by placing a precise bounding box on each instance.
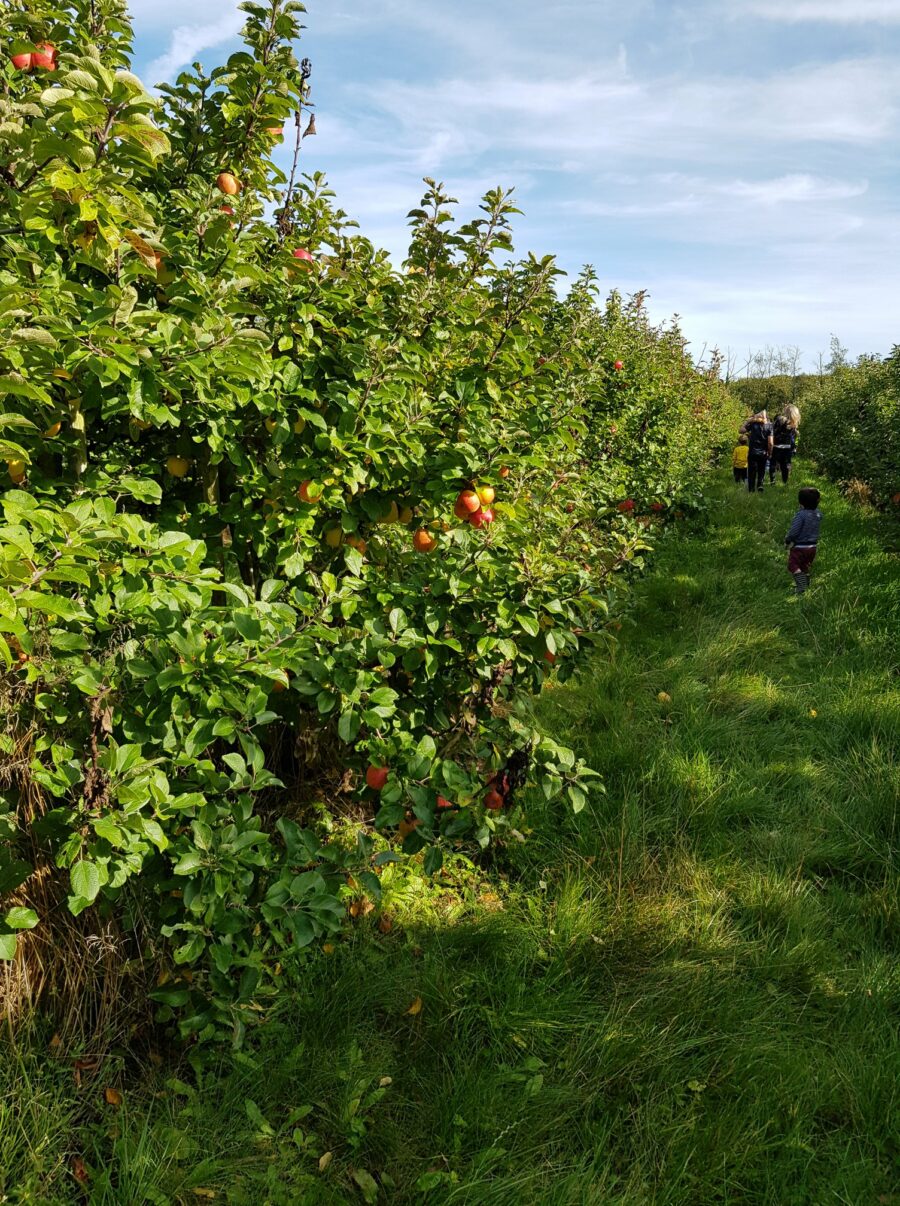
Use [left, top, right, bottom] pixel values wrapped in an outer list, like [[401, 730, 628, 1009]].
[[0, 0, 735, 1038]]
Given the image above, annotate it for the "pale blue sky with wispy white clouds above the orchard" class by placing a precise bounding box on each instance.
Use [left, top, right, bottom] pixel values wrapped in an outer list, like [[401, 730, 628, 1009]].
[[132, 0, 900, 371]]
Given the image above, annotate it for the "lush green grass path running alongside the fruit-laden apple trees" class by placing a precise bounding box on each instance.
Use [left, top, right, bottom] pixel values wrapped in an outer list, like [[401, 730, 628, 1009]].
[[0, 472, 900, 1206]]
